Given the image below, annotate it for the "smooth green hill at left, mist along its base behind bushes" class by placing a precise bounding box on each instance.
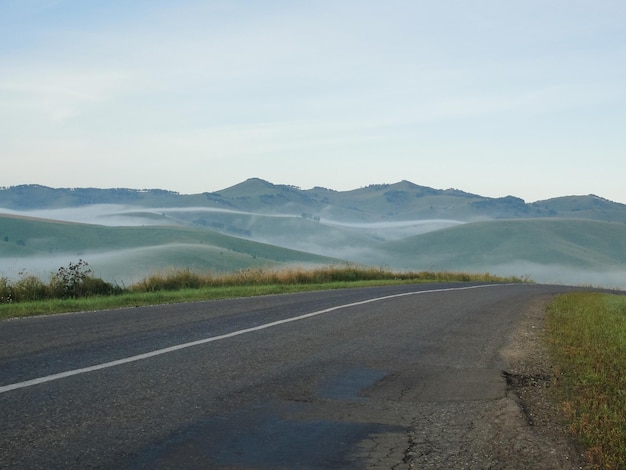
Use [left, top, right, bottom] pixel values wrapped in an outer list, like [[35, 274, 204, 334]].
[[0, 216, 339, 282]]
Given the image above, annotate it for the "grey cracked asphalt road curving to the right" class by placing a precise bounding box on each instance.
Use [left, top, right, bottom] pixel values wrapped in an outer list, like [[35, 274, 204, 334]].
[[0, 284, 567, 469]]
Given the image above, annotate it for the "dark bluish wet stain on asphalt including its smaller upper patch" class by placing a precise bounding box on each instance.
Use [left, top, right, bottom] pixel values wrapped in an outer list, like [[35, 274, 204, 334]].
[[130, 368, 408, 469]]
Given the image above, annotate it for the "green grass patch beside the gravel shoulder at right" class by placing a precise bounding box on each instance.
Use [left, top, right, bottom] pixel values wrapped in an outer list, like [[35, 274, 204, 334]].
[[546, 293, 626, 469]]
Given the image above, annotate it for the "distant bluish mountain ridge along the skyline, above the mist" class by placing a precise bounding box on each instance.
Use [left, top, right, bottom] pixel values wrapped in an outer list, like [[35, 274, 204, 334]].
[[0, 178, 626, 223]]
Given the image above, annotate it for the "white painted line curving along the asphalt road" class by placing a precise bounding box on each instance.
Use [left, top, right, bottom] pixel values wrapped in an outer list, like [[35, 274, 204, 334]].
[[0, 284, 510, 393]]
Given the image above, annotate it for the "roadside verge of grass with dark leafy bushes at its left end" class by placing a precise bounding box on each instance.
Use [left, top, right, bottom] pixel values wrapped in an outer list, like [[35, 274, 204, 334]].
[[0, 260, 527, 318]]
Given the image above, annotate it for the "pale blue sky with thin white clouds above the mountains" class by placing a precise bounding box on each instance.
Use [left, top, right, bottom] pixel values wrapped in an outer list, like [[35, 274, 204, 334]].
[[0, 0, 626, 203]]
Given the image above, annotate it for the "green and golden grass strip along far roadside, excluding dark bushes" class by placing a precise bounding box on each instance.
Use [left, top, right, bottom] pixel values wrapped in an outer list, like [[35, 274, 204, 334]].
[[0, 266, 527, 319]]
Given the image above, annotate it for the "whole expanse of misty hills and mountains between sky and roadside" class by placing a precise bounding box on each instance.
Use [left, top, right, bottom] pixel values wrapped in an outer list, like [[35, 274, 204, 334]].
[[0, 179, 626, 288]]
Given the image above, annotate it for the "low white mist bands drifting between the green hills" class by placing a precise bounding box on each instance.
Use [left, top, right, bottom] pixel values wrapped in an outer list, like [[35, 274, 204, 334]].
[[0, 204, 626, 289]]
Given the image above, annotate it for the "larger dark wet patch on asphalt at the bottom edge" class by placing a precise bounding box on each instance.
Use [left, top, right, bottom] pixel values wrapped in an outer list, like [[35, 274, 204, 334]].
[[130, 402, 406, 469]]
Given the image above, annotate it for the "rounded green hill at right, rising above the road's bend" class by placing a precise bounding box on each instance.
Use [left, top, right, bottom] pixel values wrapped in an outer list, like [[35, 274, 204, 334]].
[[379, 219, 626, 284]]
